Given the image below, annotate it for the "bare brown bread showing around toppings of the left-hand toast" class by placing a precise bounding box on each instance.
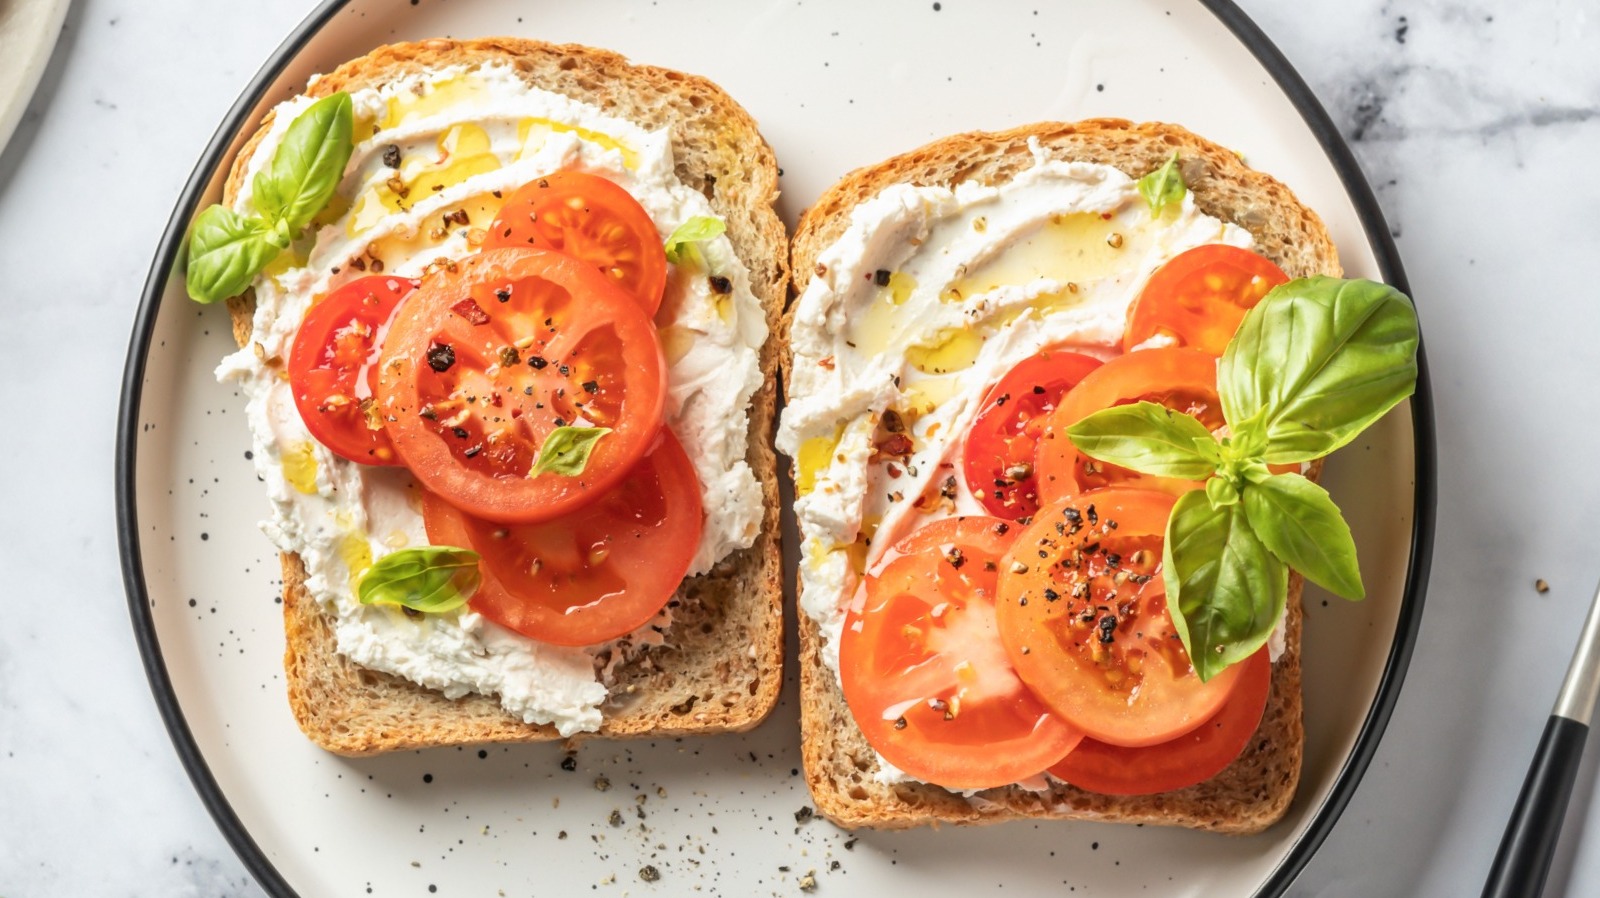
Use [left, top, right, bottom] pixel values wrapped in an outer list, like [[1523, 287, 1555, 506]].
[[224, 38, 789, 756]]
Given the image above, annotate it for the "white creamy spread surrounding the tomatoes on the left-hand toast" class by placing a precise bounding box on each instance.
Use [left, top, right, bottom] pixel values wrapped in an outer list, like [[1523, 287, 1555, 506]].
[[218, 66, 766, 736]]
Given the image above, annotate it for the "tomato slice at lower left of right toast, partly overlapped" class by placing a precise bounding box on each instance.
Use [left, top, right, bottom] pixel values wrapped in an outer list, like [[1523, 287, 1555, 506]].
[[838, 517, 1082, 789]]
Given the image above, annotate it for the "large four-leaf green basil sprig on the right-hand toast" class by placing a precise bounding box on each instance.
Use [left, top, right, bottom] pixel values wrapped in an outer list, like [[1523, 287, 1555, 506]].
[[1067, 277, 1418, 680]]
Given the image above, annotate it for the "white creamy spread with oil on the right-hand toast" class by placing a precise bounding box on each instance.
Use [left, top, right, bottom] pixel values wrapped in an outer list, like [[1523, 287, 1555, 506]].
[[778, 142, 1282, 781]]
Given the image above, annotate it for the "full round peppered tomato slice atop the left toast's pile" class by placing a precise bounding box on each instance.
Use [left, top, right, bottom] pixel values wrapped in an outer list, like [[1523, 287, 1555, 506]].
[[378, 250, 667, 523]]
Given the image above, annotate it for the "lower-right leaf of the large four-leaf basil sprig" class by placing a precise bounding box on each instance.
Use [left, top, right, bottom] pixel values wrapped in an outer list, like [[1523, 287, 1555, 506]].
[[1243, 474, 1366, 599]]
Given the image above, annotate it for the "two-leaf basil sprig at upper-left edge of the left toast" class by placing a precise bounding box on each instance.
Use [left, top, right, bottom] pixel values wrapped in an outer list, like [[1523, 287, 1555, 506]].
[[184, 91, 355, 303]]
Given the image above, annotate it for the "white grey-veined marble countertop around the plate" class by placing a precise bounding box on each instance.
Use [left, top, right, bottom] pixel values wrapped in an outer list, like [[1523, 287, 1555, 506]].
[[0, 0, 1600, 898]]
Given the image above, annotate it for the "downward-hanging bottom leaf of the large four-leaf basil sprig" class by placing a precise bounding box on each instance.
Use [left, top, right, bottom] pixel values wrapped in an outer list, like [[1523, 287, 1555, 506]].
[[1162, 490, 1288, 680]]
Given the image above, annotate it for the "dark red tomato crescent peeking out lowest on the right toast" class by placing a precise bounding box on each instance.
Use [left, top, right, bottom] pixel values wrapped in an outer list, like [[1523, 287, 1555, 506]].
[[1050, 648, 1272, 796]]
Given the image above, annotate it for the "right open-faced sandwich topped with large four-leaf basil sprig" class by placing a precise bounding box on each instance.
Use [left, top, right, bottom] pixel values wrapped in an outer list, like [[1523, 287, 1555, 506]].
[[778, 120, 1418, 832]]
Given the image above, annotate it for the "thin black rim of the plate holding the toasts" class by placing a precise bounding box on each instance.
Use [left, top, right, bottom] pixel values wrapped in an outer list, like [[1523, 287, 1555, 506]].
[[115, 0, 1437, 898]]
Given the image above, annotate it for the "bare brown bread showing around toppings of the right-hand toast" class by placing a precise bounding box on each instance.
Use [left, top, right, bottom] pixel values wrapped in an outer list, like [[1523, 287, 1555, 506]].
[[784, 118, 1341, 832]]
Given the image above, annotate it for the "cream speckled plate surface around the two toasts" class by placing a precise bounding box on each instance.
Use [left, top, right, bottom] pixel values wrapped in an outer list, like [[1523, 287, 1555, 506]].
[[117, 0, 1434, 898]]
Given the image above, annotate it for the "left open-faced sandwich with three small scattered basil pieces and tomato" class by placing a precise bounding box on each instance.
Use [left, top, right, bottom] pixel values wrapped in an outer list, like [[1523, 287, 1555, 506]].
[[187, 38, 787, 754]]
